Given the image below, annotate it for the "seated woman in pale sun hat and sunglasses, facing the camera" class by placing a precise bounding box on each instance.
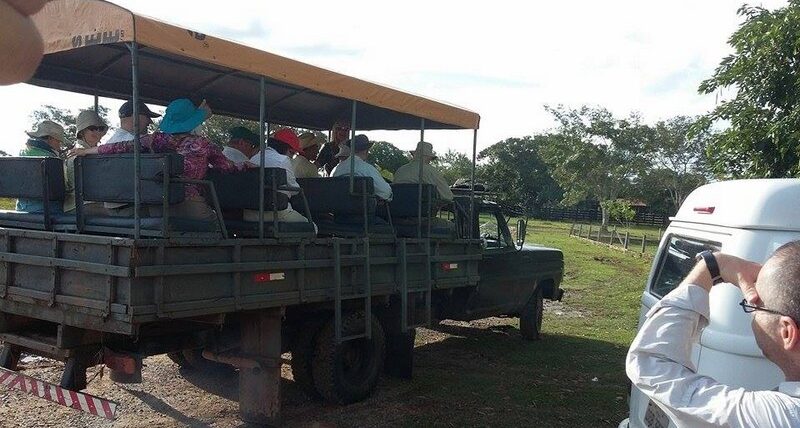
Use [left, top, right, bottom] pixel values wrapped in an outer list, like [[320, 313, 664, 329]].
[[64, 110, 108, 216]]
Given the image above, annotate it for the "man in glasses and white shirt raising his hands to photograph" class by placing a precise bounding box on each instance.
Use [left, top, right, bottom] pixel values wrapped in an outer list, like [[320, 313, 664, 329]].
[[626, 241, 800, 428]]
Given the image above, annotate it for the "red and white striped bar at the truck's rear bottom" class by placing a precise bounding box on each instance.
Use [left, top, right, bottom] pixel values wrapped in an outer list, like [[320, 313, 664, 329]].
[[0, 367, 117, 420]]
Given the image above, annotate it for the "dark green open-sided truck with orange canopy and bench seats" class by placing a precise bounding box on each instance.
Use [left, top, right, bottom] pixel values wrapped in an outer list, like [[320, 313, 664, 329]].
[[0, 0, 563, 425]]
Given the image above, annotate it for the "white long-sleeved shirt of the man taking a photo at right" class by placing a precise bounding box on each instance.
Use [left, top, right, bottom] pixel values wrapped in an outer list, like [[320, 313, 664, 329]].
[[625, 285, 800, 428]]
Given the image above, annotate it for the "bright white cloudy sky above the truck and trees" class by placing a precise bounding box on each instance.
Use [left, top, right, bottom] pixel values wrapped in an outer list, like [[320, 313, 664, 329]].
[[0, 0, 786, 157]]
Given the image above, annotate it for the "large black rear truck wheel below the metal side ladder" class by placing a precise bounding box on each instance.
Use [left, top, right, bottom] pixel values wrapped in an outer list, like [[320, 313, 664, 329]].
[[313, 312, 386, 404]]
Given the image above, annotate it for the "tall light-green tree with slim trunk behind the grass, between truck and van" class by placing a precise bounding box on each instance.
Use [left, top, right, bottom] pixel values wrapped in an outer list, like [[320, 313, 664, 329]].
[[541, 106, 655, 227]]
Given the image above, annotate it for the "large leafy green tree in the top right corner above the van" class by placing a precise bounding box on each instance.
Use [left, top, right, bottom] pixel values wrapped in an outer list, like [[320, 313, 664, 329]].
[[696, 0, 800, 177]]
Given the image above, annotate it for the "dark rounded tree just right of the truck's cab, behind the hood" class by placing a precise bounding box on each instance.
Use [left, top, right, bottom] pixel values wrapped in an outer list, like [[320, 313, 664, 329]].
[[482, 135, 562, 211]]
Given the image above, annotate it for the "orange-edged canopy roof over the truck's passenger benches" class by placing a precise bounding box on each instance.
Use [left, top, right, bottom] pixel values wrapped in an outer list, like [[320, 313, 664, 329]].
[[29, 0, 480, 130]]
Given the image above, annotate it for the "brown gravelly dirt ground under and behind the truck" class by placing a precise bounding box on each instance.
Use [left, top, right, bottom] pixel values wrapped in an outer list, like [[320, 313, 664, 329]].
[[0, 318, 536, 428]]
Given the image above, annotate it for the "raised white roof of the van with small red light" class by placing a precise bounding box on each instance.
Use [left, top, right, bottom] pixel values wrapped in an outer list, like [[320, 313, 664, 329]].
[[672, 178, 800, 230]]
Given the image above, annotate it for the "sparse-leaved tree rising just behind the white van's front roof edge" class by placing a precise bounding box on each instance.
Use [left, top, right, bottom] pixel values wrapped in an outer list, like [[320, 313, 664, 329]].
[[640, 116, 713, 213]]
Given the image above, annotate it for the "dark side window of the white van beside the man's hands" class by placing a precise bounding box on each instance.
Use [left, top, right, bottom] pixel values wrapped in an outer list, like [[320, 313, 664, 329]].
[[650, 236, 720, 298]]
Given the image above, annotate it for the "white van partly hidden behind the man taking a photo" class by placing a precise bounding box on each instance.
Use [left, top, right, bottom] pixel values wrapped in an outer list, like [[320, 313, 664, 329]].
[[620, 179, 800, 428]]
